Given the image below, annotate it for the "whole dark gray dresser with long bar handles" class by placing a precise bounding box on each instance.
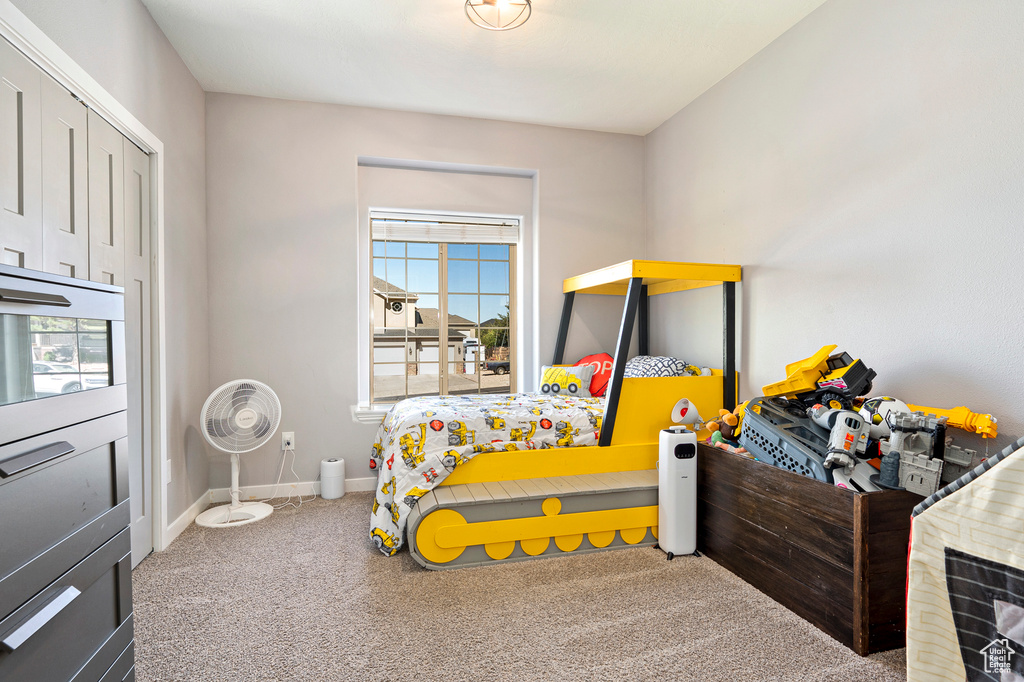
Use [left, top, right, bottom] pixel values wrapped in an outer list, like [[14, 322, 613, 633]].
[[0, 265, 134, 682]]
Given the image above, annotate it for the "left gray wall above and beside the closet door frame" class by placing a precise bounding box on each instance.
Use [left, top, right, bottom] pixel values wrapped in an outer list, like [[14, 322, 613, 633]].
[[13, 0, 209, 522]]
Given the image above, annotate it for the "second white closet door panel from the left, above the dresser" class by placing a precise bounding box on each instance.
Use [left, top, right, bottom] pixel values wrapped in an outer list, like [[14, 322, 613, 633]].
[[42, 76, 89, 280]]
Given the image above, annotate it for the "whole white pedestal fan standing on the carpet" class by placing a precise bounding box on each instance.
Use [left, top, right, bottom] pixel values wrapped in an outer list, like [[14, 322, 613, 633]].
[[196, 379, 281, 528]]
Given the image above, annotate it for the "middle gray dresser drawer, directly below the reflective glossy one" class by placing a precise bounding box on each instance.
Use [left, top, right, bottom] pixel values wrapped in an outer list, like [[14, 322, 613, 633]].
[[0, 413, 129, 619]]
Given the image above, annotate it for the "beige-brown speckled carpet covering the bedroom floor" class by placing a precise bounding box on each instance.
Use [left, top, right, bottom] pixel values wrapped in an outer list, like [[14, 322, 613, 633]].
[[132, 493, 905, 682]]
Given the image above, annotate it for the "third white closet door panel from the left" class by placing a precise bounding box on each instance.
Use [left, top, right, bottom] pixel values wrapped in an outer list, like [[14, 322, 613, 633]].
[[89, 110, 125, 287]]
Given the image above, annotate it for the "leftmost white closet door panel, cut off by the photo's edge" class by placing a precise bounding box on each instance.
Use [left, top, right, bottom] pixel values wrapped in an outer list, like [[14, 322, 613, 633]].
[[0, 38, 43, 270]]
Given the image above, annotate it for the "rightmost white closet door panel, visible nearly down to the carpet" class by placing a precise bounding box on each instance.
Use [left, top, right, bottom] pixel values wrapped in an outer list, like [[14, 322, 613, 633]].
[[124, 139, 153, 568]]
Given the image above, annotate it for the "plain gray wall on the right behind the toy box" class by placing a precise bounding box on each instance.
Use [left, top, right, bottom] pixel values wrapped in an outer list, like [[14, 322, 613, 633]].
[[646, 0, 1024, 452]]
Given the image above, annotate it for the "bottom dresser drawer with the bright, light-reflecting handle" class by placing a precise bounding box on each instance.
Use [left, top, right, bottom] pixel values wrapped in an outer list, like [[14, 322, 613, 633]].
[[0, 528, 132, 682]]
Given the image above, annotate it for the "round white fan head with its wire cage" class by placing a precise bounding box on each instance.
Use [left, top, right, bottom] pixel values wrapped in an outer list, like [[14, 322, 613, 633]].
[[201, 379, 281, 455]]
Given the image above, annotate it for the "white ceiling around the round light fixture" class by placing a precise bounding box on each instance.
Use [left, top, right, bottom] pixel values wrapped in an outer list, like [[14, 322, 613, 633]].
[[142, 0, 824, 134]]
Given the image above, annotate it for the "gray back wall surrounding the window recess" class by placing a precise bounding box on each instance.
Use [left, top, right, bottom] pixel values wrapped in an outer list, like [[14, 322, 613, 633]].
[[207, 93, 644, 487]]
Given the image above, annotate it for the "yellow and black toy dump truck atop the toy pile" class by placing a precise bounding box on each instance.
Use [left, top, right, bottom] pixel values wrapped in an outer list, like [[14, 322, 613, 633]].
[[763, 344, 876, 410]]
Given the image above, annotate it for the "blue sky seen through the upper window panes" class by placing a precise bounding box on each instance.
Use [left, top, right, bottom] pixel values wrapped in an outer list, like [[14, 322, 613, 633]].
[[374, 241, 509, 325]]
